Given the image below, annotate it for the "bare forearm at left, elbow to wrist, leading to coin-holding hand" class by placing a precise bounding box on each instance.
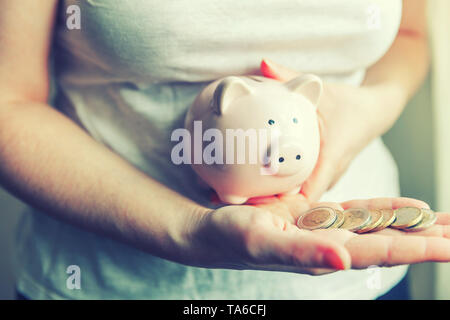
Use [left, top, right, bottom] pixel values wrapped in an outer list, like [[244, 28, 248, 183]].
[[0, 102, 207, 261]]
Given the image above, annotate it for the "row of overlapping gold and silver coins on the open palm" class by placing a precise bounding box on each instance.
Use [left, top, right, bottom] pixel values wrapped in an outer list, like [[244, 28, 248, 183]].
[[297, 207, 437, 233]]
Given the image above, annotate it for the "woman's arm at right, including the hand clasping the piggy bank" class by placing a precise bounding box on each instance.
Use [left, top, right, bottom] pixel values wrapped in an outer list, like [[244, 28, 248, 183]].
[[262, 0, 429, 201]]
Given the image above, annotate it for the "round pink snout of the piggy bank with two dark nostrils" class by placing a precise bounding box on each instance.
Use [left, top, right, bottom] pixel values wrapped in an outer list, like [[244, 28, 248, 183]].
[[269, 143, 303, 176]]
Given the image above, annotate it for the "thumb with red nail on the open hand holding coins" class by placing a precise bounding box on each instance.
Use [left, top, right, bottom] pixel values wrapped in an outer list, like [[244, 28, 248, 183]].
[[221, 203, 351, 272]]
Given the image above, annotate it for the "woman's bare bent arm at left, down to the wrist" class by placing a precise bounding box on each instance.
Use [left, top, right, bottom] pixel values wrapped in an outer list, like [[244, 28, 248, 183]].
[[0, 0, 207, 260]]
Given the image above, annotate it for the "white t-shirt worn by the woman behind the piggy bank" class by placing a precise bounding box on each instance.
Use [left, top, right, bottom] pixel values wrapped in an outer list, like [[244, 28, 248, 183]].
[[18, 0, 406, 299]]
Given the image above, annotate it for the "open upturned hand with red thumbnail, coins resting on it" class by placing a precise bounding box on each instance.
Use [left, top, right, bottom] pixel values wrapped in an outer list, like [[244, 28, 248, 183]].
[[186, 195, 450, 274]]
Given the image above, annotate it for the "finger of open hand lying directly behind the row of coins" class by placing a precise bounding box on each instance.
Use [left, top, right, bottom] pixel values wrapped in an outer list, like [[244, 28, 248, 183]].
[[341, 197, 430, 209]]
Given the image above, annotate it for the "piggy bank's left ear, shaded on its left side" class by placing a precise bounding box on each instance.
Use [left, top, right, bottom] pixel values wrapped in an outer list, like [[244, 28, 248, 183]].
[[212, 77, 252, 115]]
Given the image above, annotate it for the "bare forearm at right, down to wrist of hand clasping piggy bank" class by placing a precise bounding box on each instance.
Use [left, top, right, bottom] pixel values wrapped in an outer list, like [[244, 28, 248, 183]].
[[362, 1, 430, 134]]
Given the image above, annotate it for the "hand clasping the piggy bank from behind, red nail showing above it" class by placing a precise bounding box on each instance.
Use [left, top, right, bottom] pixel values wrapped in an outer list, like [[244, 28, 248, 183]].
[[261, 60, 404, 201]]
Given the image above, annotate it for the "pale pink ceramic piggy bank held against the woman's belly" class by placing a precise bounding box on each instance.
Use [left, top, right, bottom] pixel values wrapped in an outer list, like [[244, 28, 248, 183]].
[[185, 74, 322, 204]]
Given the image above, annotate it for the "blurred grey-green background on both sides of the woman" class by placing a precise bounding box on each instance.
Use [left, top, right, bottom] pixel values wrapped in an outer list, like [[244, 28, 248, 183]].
[[0, 0, 450, 299]]
